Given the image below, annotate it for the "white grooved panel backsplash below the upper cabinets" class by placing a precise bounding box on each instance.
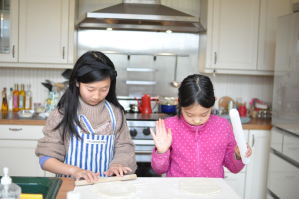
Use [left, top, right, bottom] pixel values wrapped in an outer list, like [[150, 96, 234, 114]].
[[0, 68, 273, 108]]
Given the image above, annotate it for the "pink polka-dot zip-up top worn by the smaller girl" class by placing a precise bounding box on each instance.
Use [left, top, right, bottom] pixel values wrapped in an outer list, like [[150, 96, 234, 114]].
[[151, 115, 245, 178]]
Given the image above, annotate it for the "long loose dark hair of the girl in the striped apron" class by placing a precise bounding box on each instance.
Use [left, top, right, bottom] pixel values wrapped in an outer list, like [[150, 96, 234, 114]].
[[54, 51, 124, 140]]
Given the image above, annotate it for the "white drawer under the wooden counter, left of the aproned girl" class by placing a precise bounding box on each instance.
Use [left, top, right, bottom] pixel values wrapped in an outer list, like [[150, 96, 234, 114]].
[[0, 125, 44, 140]]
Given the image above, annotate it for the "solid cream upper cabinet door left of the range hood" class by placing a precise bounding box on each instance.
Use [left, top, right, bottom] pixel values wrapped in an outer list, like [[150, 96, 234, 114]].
[[19, 0, 69, 63]]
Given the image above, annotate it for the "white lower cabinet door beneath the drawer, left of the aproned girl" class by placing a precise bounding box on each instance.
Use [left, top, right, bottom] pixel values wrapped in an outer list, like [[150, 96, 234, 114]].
[[0, 140, 45, 177]]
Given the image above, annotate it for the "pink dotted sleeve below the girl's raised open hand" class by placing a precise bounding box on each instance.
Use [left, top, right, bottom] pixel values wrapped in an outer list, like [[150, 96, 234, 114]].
[[151, 147, 170, 175]]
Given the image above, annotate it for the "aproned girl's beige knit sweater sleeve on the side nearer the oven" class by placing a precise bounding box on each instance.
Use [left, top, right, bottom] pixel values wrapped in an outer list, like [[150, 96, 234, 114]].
[[109, 108, 137, 174]]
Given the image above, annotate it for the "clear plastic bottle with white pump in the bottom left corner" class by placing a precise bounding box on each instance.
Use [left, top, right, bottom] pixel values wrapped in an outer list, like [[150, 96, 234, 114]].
[[0, 167, 21, 199]]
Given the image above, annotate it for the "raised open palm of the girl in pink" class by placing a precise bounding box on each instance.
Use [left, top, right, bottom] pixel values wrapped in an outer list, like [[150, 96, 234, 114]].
[[150, 119, 172, 153]]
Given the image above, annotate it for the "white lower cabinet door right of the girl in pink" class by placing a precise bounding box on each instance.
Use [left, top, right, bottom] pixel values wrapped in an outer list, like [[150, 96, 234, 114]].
[[245, 130, 270, 199]]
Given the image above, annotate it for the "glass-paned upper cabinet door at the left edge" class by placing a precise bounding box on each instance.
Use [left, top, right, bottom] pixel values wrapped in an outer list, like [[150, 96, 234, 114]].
[[0, 0, 19, 62]]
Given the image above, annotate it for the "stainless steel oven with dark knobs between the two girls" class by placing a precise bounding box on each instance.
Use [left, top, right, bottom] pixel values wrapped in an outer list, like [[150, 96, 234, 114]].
[[125, 113, 167, 177]]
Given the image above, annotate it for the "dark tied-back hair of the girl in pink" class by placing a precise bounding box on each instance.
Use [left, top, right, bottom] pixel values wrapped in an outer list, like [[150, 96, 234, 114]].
[[178, 74, 215, 117]]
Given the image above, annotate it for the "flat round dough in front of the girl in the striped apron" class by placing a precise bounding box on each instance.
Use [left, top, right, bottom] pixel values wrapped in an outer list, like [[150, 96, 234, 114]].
[[93, 181, 136, 198]]
